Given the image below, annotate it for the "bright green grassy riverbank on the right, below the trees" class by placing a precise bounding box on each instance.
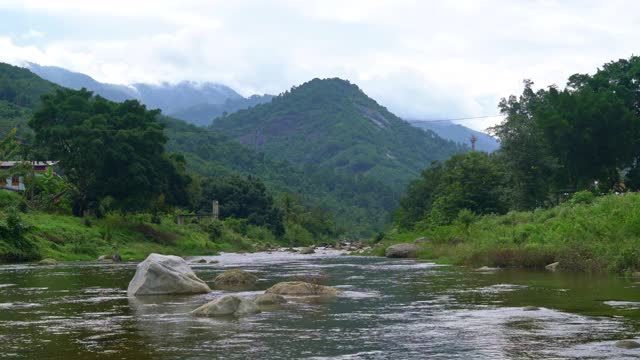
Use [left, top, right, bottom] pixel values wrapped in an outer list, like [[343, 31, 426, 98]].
[[373, 194, 640, 273]]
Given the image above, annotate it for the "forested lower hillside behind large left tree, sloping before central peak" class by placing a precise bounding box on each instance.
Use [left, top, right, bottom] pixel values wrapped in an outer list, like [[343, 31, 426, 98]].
[[0, 63, 399, 234]]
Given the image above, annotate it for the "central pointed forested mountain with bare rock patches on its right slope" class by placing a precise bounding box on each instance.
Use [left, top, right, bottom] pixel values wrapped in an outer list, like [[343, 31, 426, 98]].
[[212, 78, 466, 187]]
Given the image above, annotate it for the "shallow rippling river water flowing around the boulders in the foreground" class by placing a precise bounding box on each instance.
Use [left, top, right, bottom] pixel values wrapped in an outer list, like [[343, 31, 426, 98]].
[[0, 250, 640, 359]]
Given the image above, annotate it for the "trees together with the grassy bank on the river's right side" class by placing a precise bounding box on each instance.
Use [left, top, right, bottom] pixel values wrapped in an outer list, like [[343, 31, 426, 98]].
[[374, 56, 640, 274]]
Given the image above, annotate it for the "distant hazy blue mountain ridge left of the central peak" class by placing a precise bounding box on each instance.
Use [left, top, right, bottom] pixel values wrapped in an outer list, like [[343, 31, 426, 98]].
[[27, 63, 273, 125]]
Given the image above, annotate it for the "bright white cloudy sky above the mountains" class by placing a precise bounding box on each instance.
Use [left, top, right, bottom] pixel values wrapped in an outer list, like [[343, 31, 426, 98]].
[[0, 0, 640, 130]]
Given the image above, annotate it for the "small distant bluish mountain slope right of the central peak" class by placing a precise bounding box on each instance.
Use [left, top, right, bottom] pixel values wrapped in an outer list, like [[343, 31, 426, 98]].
[[409, 120, 500, 152]]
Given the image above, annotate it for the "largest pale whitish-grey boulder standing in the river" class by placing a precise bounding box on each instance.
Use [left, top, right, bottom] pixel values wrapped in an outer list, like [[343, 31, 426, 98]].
[[127, 254, 211, 296]]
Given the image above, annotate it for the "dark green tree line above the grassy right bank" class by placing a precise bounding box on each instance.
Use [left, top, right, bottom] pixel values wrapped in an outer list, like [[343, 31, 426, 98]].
[[395, 56, 640, 228]]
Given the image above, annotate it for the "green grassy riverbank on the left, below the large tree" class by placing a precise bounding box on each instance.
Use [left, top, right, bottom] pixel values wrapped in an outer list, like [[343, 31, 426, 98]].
[[0, 212, 305, 263]]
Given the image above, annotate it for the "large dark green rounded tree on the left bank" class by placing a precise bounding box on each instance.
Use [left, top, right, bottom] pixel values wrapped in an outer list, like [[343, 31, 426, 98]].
[[29, 89, 189, 215]]
